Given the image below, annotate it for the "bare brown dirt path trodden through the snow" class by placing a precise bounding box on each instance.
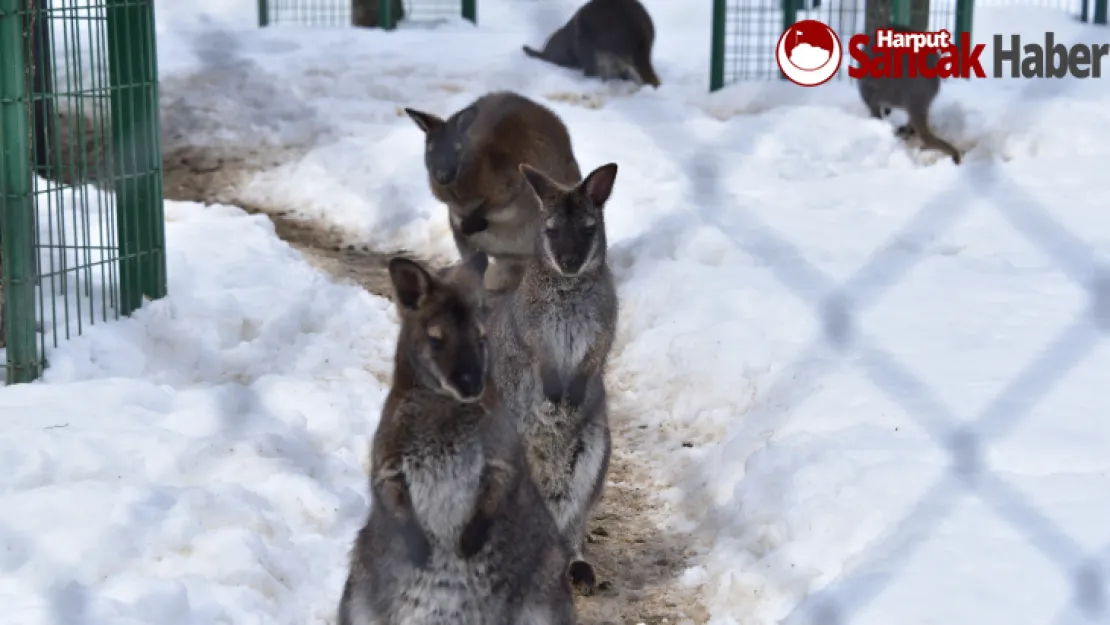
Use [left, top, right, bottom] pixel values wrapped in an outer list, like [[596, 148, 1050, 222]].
[[157, 138, 707, 625]]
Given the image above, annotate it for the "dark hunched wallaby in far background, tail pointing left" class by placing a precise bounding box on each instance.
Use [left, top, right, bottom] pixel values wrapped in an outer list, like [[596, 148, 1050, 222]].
[[524, 0, 659, 88]]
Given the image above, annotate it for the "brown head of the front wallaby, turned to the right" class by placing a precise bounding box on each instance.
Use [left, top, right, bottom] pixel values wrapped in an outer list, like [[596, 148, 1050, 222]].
[[389, 254, 490, 403]]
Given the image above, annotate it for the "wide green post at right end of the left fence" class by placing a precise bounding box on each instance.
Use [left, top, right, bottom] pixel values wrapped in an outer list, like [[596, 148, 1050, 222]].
[[108, 0, 165, 314]]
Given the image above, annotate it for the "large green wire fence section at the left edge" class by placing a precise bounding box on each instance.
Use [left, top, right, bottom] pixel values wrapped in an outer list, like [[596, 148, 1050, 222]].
[[0, 0, 165, 383]]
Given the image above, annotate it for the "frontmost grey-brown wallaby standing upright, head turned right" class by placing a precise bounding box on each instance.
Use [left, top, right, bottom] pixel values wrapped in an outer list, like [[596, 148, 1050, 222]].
[[337, 254, 575, 625]]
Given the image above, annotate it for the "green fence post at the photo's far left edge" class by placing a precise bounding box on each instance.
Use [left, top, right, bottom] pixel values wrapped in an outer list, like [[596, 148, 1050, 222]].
[[0, 0, 42, 384]]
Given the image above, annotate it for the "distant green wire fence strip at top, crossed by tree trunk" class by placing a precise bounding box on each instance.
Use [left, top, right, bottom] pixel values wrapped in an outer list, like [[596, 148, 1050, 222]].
[[259, 0, 477, 29]]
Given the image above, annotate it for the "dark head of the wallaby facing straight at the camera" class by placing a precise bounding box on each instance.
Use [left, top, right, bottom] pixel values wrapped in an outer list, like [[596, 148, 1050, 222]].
[[521, 163, 617, 278]]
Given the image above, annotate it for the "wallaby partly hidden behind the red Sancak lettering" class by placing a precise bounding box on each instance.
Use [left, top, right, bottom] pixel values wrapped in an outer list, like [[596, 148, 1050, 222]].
[[858, 24, 961, 164]]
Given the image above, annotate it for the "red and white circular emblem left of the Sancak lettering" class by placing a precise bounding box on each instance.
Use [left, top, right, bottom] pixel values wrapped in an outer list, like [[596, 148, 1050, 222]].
[[775, 20, 844, 87]]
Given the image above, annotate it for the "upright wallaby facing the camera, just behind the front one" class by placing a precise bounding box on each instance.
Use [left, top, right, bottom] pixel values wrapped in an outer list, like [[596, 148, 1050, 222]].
[[491, 163, 618, 594]]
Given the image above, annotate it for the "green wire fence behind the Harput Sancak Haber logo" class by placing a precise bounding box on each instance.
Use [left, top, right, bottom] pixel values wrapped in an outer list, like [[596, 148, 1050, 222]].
[[709, 0, 1107, 91]]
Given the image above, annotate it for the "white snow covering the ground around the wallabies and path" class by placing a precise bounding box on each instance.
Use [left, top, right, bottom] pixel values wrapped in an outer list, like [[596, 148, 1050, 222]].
[[0, 0, 1110, 625]]
